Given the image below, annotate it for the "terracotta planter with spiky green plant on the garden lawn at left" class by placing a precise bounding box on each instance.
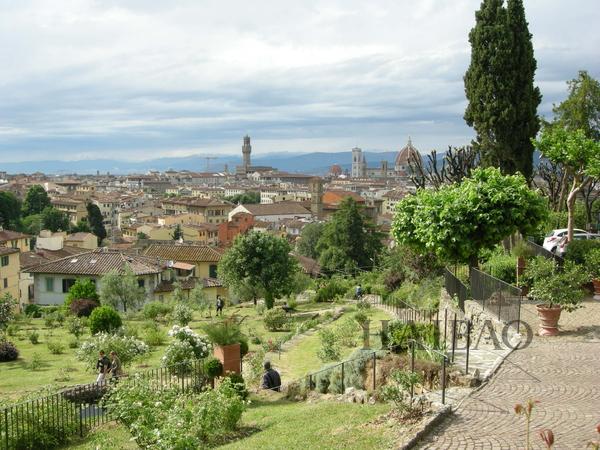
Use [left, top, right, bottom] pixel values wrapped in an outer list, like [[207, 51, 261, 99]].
[[204, 318, 246, 373]]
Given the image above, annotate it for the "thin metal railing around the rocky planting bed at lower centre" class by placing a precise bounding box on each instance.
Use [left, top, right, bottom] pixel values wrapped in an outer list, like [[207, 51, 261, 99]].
[[305, 339, 449, 404]]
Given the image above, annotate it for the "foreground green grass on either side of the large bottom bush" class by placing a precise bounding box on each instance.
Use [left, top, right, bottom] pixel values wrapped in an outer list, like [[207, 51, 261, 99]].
[[69, 397, 395, 450]]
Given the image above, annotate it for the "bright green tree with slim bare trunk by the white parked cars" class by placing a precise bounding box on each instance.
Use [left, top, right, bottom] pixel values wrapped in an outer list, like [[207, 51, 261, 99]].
[[534, 126, 600, 241]]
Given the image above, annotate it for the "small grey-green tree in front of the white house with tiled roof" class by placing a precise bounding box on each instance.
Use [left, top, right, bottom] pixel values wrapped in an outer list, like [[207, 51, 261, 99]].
[[100, 266, 146, 311]]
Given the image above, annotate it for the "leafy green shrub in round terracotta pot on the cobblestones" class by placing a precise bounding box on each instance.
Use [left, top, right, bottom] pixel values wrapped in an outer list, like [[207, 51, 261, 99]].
[[529, 261, 589, 336]]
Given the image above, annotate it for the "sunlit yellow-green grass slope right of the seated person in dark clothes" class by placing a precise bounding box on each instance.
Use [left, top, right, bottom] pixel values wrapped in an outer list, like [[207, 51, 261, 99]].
[[268, 308, 391, 383]]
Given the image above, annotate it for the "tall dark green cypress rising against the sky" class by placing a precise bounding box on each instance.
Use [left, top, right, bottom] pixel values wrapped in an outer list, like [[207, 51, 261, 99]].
[[464, 0, 541, 178]]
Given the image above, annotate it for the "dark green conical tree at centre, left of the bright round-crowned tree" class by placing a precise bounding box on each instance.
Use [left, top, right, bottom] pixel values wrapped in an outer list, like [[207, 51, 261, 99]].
[[317, 197, 383, 274]]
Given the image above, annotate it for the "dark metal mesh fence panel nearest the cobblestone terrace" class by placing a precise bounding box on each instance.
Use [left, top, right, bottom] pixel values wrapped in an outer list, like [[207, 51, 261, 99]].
[[471, 268, 521, 330]]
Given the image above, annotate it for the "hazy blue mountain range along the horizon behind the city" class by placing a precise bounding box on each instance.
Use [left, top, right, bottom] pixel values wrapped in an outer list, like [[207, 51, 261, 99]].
[[0, 151, 397, 175]]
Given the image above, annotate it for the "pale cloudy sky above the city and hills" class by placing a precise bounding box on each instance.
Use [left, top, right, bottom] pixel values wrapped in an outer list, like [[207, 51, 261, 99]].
[[0, 0, 600, 161]]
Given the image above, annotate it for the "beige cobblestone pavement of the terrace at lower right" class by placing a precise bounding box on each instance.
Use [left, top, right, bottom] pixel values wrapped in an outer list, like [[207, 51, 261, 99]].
[[419, 301, 600, 449]]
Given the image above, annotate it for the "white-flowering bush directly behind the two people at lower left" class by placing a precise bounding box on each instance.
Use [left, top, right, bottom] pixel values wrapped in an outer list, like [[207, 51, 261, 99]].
[[75, 332, 150, 368]]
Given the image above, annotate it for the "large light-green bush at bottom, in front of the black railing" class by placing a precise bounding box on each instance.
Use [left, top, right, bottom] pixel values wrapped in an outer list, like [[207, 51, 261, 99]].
[[104, 378, 247, 449]]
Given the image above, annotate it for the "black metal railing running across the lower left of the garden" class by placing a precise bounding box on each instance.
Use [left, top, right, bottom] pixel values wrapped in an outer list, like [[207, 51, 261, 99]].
[[0, 360, 208, 450]]
